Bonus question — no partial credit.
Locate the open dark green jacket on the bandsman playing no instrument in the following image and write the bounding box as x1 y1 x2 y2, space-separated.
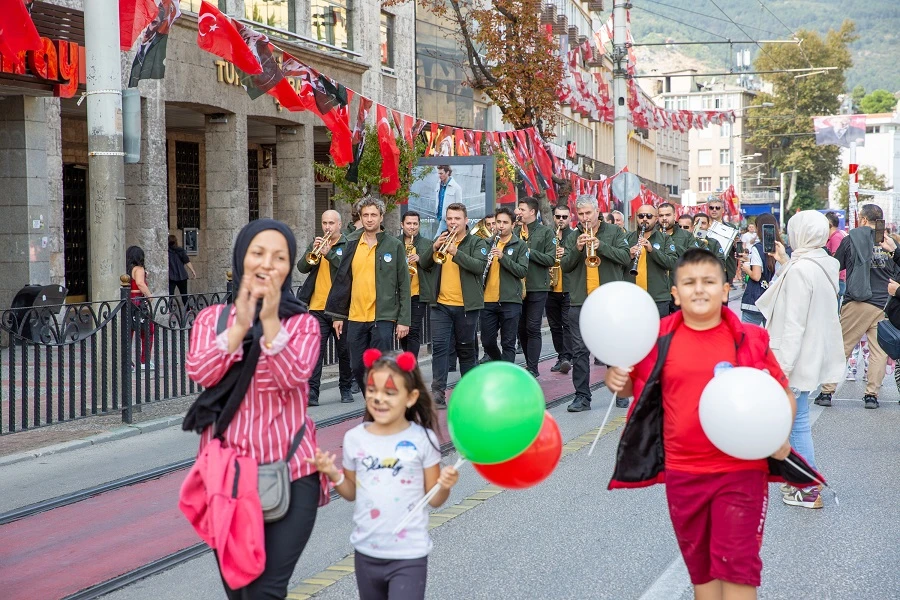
325 229 410 326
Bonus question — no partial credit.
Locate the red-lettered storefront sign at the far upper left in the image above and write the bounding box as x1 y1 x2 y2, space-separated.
0 38 87 98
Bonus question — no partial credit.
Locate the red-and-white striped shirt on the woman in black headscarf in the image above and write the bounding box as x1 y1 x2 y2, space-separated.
185 304 329 506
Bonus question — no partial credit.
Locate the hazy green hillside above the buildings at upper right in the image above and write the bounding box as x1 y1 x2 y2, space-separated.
620 0 900 92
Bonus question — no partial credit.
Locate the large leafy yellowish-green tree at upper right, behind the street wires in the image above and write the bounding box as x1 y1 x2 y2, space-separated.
745 20 857 194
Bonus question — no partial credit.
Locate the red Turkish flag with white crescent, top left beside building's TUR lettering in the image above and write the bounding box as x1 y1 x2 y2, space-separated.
196 0 268 75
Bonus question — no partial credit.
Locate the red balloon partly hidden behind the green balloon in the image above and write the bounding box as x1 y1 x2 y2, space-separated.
472 412 562 490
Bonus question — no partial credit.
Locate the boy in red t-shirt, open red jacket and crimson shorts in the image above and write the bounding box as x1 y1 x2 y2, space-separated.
606 249 796 600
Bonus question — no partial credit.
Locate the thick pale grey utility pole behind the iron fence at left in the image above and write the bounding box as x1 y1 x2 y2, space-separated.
84 0 125 301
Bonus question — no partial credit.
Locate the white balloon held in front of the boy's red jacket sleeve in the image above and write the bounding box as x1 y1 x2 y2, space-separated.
700 367 791 460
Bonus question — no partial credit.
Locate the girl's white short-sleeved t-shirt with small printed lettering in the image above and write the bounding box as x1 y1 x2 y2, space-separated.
343 423 441 559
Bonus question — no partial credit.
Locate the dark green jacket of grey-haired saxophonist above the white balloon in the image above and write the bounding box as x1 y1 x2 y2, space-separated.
561 222 631 306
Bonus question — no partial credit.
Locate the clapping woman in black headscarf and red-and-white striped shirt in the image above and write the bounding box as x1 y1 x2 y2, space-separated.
183 219 328 600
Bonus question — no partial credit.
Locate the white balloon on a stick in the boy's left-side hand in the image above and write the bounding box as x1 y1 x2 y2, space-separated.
578 281 659 368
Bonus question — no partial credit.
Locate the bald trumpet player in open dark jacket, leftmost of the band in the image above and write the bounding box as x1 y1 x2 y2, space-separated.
297 210 353 406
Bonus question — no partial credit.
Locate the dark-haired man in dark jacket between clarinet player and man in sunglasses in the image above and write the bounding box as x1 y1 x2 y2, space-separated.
515 196 556 377
